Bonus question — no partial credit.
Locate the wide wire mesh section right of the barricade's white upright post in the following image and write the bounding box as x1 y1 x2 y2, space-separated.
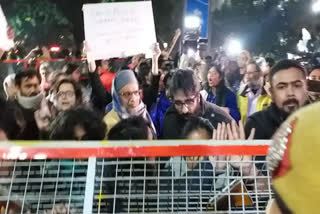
93 157 272 213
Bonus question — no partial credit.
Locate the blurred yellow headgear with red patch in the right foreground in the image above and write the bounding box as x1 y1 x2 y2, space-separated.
266 101 320 214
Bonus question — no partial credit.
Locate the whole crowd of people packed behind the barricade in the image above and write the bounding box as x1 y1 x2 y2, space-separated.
0 26 320 212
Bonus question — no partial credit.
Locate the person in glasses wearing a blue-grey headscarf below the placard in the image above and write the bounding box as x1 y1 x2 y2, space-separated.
103 70 157 138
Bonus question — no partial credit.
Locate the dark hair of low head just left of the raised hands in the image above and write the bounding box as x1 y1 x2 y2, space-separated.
182 117 214 139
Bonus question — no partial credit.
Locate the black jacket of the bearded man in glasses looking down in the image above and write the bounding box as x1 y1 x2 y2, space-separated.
161 98 232 140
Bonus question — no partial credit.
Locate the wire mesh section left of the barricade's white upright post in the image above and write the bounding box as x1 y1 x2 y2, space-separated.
0 159 87 213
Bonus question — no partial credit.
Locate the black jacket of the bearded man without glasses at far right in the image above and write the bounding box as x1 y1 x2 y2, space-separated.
245 103 288 140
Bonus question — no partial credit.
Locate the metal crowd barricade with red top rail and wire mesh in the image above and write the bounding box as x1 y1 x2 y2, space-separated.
0 141 273 214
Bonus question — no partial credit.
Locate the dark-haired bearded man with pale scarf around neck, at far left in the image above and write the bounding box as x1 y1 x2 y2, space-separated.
15 70 43 140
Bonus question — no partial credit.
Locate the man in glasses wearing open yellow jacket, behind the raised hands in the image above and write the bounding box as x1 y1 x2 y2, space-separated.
238 62 271 122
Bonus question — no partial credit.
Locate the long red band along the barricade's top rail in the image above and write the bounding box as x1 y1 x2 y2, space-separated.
0 144 269 160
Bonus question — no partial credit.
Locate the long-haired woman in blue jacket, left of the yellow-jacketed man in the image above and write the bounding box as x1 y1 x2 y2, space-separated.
200 66 240 121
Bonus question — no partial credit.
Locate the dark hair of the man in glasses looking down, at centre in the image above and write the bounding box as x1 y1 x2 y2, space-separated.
170 70 200 95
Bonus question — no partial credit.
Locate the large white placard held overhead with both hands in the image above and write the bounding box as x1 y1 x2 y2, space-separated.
83 1 156 60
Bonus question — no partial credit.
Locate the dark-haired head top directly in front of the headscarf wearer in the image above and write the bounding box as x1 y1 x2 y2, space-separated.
108 117 150 140
